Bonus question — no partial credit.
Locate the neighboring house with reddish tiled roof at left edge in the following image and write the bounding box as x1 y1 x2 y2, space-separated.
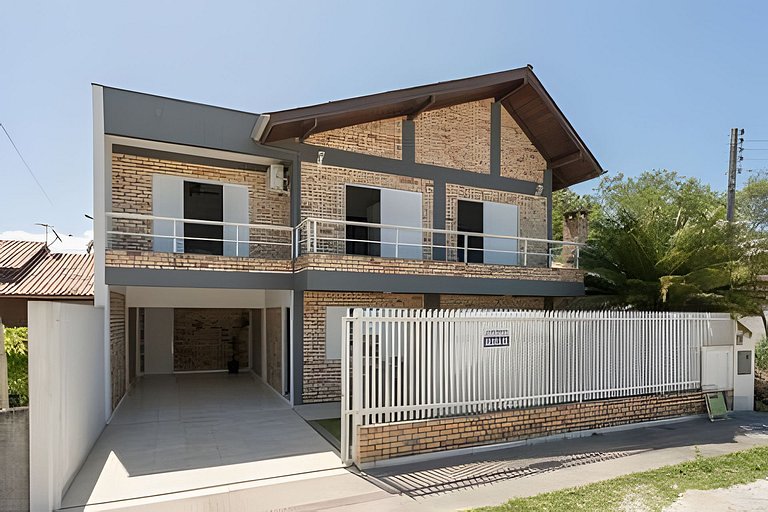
0 240 93 327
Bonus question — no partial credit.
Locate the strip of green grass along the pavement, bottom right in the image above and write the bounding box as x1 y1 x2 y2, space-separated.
476 447 768 512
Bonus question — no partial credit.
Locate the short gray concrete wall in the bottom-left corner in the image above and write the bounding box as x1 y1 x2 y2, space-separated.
0 407 29 512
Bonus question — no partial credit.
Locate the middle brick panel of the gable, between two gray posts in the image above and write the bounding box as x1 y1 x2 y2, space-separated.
414 99 493 174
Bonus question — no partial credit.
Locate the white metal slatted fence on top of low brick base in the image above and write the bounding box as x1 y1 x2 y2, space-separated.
342 309 731 460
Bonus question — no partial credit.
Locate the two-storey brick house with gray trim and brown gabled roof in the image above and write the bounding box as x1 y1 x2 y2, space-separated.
93 68 603 408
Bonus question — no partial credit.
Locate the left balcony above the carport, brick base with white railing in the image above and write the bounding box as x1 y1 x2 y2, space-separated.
106 212 293 272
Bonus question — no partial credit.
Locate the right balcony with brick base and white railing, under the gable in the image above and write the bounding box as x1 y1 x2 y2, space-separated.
294 218 583 281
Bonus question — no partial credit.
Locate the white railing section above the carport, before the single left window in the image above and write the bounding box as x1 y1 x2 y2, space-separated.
107 212 293 259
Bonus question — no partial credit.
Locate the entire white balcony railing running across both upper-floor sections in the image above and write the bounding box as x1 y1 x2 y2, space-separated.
107 212 583 268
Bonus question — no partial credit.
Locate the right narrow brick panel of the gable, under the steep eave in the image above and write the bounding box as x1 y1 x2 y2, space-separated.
501 107 547 183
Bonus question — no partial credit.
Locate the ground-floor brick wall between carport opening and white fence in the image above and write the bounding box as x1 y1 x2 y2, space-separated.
303 292 424 403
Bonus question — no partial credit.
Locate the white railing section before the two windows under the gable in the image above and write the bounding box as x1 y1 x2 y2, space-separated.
294 218 583 268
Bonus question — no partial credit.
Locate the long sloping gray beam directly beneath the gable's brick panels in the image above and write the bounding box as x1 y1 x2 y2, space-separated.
273 142 539 195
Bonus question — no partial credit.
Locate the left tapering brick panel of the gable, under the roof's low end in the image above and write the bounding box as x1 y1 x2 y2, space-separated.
305 118 403 160
